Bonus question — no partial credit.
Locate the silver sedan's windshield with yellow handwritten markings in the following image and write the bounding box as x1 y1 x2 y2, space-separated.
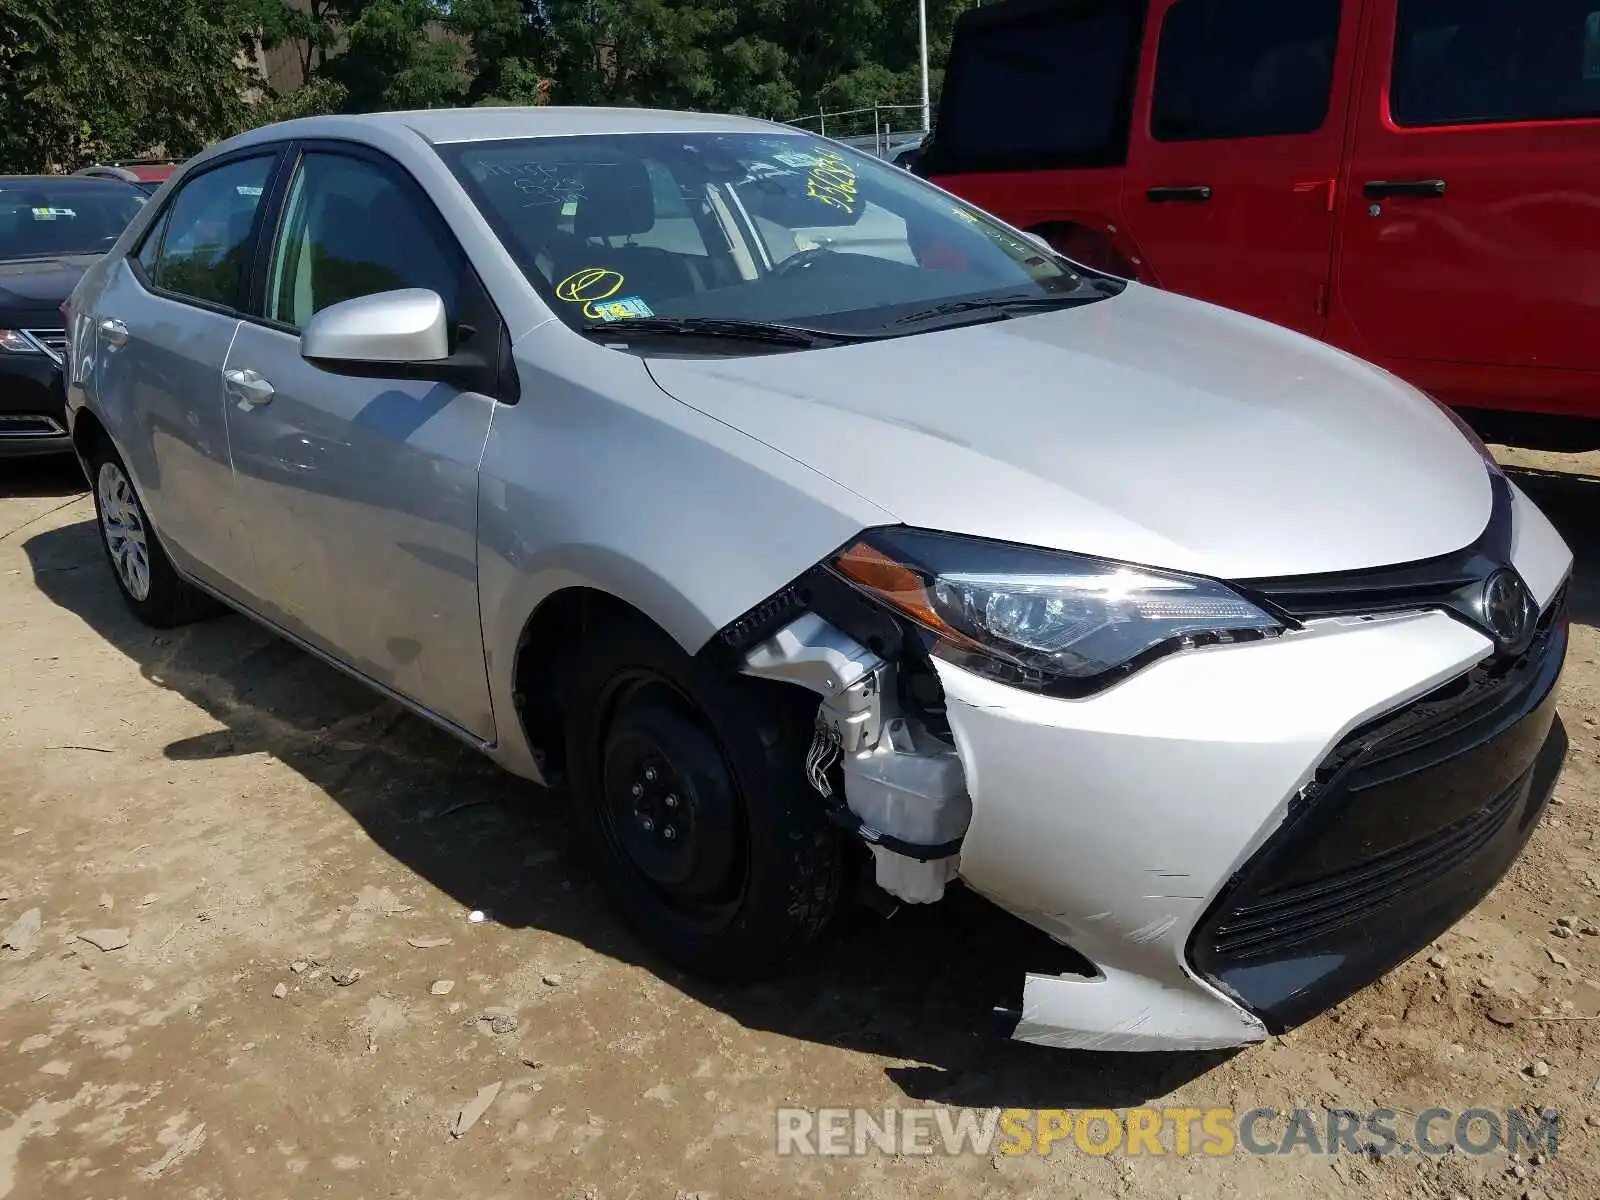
440 131 1120 336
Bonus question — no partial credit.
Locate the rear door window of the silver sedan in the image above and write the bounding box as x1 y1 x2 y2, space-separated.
139 154 274 307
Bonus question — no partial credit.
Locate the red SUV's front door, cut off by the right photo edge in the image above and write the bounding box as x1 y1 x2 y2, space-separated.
1339 0 1600 403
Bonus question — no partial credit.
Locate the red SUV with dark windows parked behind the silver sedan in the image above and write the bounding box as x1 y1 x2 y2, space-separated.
917 0 1600 448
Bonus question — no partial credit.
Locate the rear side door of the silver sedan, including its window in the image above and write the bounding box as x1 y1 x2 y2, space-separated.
85 149 277 590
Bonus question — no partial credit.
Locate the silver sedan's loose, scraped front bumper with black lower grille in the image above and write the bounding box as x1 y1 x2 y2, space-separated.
939 605 1566 1051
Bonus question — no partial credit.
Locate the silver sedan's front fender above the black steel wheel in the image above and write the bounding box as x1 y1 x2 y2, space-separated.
478 322 893 779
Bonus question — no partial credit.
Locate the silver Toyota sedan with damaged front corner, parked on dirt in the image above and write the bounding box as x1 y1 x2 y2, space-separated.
67 109 1571 1050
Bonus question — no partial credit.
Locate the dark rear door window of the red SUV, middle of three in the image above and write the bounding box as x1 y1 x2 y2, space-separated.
1150 0 1350 142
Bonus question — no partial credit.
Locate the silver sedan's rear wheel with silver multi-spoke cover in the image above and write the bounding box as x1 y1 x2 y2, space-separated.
90 440 222 629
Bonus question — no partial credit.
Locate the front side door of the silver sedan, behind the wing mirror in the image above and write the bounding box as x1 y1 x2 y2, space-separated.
224 144 496 741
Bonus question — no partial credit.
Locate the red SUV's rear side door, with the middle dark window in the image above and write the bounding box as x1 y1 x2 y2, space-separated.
1122 0 1360 336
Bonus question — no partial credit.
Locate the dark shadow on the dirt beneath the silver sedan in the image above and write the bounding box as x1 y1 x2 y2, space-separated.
24 522 1229 1109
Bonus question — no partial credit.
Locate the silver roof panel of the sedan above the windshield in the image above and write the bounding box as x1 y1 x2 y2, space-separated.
227 106 800 146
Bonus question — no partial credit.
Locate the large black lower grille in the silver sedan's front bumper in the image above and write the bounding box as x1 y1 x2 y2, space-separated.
1189 594 1568 1030
